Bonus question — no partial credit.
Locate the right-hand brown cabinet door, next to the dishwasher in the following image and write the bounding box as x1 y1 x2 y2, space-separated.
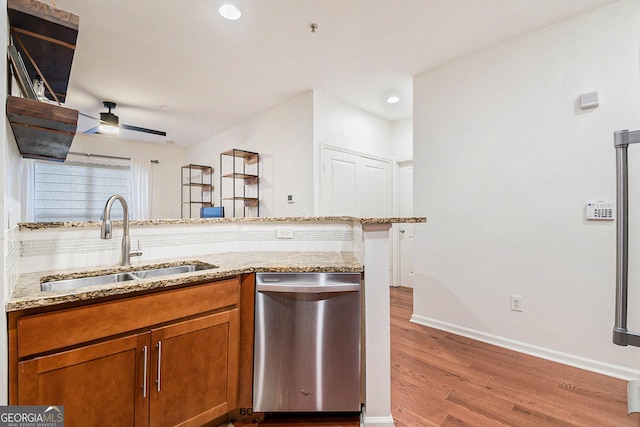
149 309 239 426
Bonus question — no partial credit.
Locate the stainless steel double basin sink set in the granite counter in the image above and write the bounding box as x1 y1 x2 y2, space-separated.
40 263 217 292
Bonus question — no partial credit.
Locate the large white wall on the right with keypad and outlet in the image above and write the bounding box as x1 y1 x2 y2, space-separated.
414 0 640 376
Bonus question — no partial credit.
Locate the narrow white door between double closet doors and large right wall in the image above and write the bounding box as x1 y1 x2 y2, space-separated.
398 162 413 288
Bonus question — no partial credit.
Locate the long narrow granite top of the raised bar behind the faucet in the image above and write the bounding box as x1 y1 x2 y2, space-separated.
18 216 427 230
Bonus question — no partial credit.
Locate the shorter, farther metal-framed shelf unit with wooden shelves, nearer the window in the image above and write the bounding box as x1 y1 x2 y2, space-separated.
180 164 213 218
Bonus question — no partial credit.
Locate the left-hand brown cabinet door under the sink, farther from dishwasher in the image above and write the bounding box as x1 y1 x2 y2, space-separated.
18 333 149 427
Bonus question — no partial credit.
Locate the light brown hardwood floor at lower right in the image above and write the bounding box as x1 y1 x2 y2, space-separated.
391 288 640 427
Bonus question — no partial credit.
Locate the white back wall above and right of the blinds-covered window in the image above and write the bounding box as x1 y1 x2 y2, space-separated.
70 133 188 219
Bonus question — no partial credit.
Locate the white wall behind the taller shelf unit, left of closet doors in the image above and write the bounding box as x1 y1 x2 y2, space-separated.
188 91 313 217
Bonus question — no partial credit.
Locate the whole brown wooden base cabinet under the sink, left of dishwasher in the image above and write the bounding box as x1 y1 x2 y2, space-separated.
9 277 240 426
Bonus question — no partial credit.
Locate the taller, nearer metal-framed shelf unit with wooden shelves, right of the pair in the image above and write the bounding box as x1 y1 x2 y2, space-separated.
220 148 260 217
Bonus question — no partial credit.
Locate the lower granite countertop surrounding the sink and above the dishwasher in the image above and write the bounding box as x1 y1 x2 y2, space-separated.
6 252 363 312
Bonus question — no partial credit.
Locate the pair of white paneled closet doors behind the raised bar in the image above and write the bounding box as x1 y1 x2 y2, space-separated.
320 147 392 217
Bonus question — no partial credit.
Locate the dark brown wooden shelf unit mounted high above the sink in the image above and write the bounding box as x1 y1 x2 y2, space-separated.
7 0 80 161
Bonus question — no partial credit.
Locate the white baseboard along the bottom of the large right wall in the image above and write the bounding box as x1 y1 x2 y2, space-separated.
411 314 640 381
